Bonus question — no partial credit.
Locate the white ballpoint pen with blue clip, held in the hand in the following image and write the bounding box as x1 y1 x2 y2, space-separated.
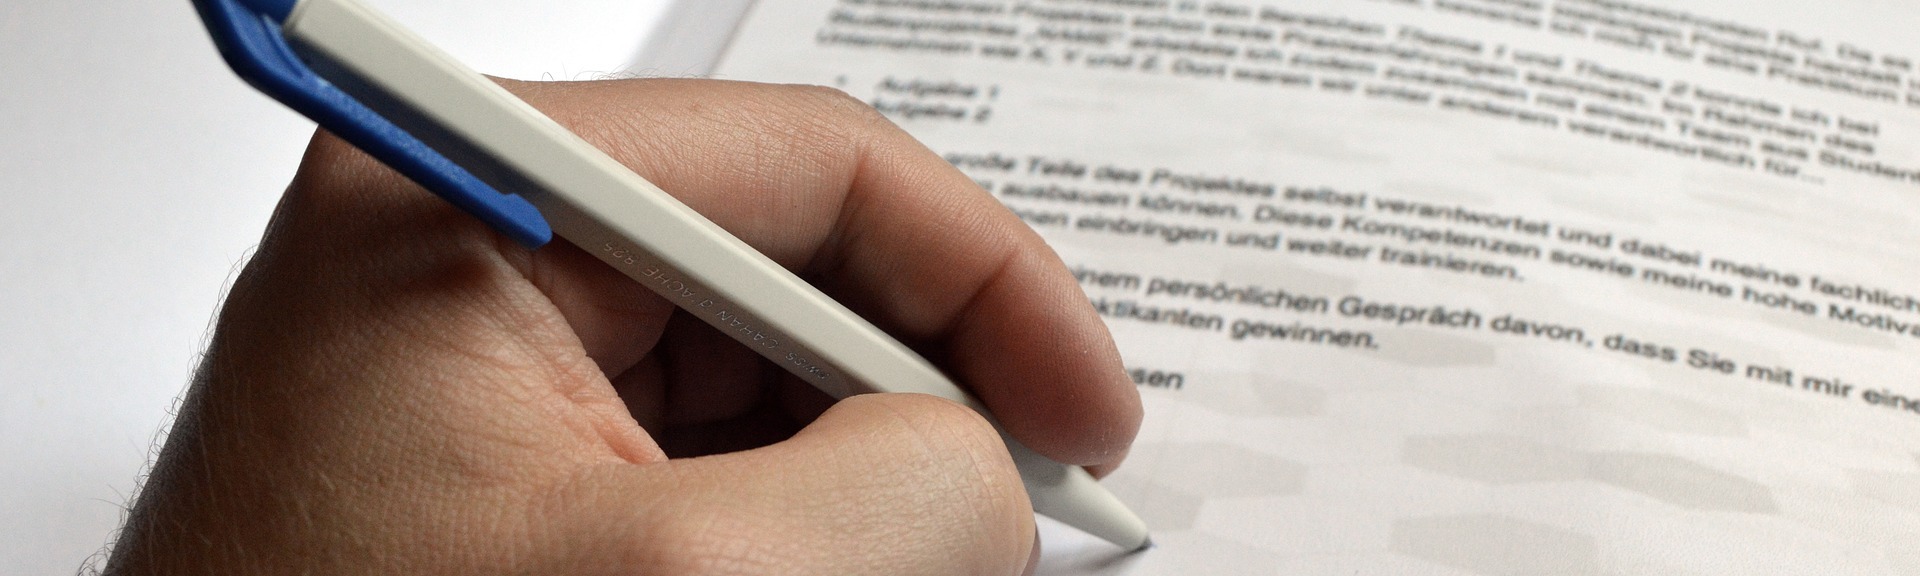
194 0 1148 549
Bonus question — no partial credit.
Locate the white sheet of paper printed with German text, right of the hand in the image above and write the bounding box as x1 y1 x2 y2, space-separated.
698 0 1920 574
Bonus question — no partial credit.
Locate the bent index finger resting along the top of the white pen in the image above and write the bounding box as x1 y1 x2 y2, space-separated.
515 81 1140 465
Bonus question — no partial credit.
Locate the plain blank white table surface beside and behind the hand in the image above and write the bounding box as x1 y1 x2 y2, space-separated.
0 0 674 574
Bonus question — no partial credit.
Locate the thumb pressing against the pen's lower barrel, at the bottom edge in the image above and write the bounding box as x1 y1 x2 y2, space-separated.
545 394 1035 574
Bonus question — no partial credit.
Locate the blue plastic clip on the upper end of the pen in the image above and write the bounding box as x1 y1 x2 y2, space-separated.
194 0 553 248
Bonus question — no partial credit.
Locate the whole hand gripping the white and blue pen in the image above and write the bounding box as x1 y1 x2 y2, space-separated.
108 81 1140 574
